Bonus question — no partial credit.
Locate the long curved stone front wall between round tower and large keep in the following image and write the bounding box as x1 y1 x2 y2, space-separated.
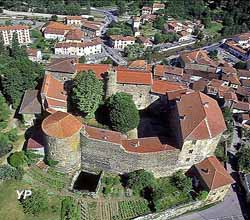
80 133 181 177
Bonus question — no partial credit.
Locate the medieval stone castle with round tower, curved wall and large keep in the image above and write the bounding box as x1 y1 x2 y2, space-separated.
42 65 226 177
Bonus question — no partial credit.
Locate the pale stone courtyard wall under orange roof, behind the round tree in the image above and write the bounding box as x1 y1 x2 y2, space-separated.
116 83 151 109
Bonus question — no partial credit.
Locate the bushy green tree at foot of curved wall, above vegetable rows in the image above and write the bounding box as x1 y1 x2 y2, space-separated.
127 170 156 194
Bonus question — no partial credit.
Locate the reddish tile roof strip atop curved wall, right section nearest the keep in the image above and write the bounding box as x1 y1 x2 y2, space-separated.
122 137 176 153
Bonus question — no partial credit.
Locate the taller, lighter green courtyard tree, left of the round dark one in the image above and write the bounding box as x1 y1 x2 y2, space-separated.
72 71 103 118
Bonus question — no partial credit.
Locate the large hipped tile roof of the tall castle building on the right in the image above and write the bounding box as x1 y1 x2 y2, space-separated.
177 92 226 140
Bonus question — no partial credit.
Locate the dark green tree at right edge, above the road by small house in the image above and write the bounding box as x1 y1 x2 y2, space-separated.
236 144 250 173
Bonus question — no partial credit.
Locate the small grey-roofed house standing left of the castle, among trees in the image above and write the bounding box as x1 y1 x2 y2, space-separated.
18 90 42 126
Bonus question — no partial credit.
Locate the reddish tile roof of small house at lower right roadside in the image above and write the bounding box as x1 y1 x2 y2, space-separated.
194 156 235 190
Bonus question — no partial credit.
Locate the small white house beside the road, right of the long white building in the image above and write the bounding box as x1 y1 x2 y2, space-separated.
110 35 135 50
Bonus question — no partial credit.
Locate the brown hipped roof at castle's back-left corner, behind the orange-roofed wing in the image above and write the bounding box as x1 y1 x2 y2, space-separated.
46 58 77 74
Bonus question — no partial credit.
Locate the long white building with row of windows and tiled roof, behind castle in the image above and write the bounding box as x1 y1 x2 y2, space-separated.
55 39 102 57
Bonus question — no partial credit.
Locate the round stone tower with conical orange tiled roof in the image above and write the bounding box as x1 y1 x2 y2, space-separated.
42 112 82 173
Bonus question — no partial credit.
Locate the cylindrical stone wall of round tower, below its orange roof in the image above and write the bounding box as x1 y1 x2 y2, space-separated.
44 131 81 173
